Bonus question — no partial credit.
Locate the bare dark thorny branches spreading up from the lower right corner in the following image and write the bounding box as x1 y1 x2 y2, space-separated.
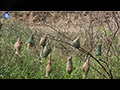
39 12 119 79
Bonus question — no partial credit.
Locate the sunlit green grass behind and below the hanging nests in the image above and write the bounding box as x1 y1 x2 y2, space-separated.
0 19 120 79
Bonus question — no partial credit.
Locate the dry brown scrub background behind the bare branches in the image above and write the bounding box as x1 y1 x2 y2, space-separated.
0 11 120 79
